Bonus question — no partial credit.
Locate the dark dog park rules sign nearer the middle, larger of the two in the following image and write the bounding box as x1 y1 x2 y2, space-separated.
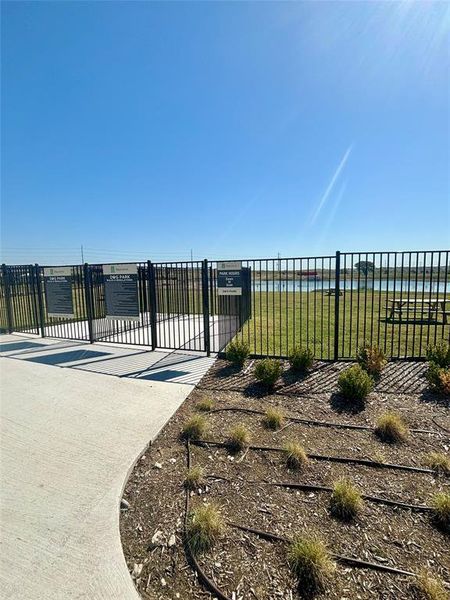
103 263 139 321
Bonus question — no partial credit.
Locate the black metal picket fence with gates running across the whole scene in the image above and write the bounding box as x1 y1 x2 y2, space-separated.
0 250 450 360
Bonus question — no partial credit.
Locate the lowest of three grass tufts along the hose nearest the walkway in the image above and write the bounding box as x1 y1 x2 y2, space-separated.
186 504 224 554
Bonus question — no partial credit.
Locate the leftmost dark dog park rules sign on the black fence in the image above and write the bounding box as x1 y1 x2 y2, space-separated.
44 267 75 317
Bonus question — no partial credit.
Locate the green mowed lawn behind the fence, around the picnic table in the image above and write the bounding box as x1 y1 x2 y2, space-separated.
239 289 450 359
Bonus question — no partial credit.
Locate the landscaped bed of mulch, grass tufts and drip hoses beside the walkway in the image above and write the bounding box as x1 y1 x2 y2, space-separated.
120 360 450 600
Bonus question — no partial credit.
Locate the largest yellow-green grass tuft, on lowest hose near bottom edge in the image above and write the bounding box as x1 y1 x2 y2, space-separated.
287 536 334 592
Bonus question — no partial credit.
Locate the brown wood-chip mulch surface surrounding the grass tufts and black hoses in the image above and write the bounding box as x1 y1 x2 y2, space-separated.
120 360 450 600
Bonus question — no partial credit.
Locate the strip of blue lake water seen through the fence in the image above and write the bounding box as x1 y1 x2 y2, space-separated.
252 279 450 296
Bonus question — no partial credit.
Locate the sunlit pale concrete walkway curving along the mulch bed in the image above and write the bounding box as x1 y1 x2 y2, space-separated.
0 336 197 600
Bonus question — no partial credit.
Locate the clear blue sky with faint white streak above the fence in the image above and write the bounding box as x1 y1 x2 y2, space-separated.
1 1 450 264
